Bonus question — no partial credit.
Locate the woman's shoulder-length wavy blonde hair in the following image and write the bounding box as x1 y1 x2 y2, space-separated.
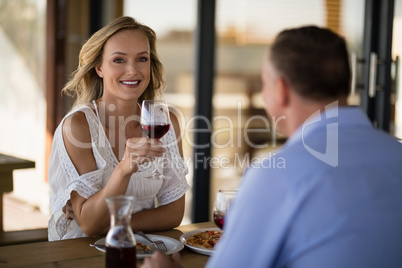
62 17 165 107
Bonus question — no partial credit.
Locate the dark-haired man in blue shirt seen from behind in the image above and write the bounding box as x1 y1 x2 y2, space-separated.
139 26 402 268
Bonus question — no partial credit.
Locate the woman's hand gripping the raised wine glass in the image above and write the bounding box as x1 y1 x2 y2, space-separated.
120 137 166 174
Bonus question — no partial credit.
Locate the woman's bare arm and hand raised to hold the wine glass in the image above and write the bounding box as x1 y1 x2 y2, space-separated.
63 112 165 236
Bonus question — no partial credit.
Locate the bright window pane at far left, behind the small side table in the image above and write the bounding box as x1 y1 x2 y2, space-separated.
0 0 48 231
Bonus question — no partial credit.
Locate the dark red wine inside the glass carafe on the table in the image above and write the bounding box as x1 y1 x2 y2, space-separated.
106 246 136 268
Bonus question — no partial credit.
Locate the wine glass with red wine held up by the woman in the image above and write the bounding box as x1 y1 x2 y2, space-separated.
141 100 170 179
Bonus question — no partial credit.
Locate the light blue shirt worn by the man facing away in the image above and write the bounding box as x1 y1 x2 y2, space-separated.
208 107 402 268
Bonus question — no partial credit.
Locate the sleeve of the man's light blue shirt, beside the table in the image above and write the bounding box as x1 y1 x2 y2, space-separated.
207 165 294 267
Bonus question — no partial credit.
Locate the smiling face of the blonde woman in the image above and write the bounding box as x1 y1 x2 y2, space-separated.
96 30 151 101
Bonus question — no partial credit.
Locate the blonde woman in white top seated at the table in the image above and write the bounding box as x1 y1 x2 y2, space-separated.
49 17 189 241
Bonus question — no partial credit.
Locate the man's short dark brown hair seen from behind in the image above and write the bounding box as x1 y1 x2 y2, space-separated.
270 26 350 99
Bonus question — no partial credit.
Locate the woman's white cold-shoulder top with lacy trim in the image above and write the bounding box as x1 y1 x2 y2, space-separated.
48 102 190 241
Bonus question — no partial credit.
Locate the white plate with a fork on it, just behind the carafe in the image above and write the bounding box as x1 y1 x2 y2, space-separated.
94 234 184 259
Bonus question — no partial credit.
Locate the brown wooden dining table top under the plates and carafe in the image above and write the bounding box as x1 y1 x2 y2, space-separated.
0 222 216 268
